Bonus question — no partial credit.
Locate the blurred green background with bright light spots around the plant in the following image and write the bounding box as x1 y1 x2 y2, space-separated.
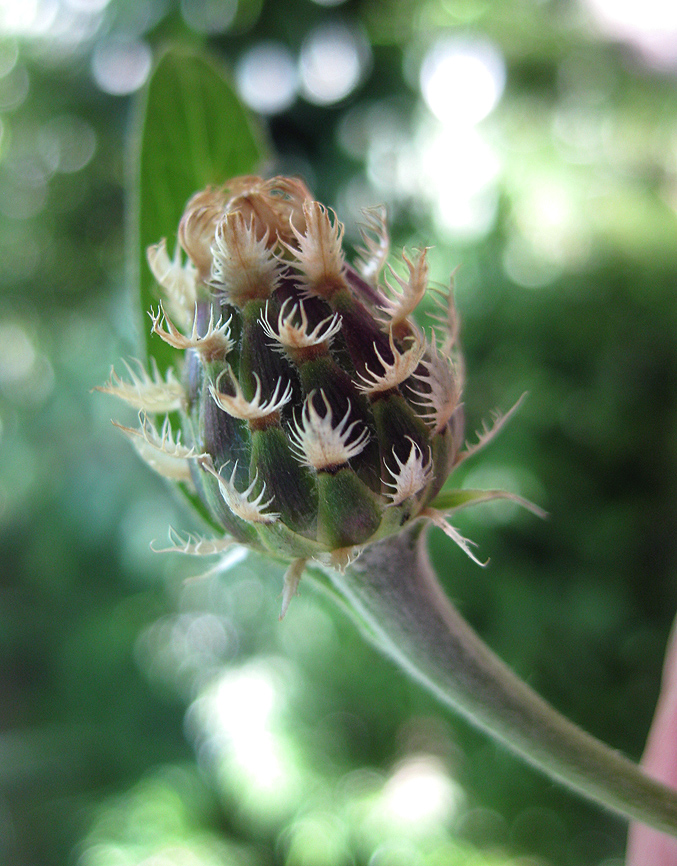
0 0 677 866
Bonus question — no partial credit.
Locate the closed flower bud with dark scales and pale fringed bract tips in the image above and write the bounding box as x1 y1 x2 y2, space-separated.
102 177 532 613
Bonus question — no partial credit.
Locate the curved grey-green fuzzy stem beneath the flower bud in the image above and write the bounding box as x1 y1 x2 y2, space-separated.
310 526 677 836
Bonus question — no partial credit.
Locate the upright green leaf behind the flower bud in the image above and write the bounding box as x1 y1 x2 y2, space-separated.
129 48 266 371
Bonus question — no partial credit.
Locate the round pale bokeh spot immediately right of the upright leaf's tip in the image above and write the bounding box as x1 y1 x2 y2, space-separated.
235 42 297 114
